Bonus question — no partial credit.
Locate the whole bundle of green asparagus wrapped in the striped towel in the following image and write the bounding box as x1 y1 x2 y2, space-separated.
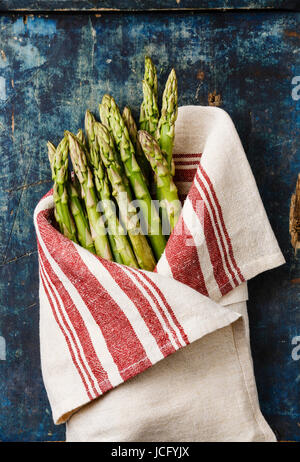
48 57 181 271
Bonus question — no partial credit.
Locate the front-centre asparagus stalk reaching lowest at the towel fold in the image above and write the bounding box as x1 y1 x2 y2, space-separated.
94 122 156 271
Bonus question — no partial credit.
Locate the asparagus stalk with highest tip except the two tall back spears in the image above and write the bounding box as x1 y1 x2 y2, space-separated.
100 95 166 259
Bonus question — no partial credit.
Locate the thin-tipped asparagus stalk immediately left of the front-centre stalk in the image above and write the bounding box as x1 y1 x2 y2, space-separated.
85 111 138 268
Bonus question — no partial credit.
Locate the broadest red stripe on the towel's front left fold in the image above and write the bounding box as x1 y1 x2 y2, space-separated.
37 210 152 380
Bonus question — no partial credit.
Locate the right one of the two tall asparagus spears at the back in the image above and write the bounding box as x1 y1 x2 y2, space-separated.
156 69 178 175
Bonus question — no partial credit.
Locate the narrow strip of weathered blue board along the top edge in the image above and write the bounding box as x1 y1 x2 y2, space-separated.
0 0 300 12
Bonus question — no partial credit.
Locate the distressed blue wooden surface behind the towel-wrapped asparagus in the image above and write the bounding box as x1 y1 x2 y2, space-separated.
0 6 300 441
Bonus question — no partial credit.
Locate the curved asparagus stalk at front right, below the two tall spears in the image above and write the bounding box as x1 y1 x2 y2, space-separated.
138 130 181 232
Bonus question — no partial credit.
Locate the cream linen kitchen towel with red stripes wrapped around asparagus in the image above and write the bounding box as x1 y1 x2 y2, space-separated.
34 106 284 441
